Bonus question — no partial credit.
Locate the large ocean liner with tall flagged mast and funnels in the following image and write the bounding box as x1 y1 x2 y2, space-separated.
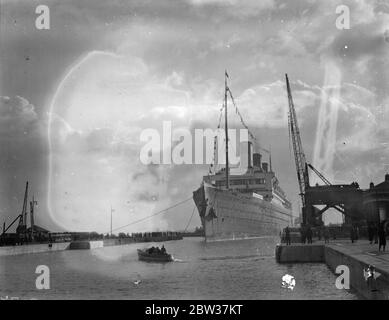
193 72 292 241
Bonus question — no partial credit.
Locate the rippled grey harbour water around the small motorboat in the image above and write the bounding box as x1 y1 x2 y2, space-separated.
0 238 356 299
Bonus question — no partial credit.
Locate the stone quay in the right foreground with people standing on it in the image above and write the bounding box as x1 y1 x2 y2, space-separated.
276 240 389 300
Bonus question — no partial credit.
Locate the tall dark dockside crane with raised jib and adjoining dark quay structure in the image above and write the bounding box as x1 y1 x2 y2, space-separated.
285 75 389 226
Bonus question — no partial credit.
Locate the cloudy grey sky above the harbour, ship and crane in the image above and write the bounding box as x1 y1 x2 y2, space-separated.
0 0 389 233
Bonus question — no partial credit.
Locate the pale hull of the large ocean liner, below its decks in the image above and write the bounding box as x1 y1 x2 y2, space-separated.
193 183 292 241
